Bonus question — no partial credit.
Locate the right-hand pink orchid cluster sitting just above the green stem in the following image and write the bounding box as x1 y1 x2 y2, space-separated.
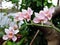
33 7 55 23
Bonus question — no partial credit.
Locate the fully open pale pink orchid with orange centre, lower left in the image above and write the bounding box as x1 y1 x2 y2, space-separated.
3 27 19 41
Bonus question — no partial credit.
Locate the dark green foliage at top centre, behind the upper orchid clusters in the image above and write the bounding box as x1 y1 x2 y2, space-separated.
20 0 52 12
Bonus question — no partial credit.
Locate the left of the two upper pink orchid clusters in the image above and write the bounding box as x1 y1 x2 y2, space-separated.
15 7 33 21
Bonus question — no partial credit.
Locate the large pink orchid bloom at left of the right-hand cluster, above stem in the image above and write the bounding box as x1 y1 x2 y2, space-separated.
33 11 47 23
